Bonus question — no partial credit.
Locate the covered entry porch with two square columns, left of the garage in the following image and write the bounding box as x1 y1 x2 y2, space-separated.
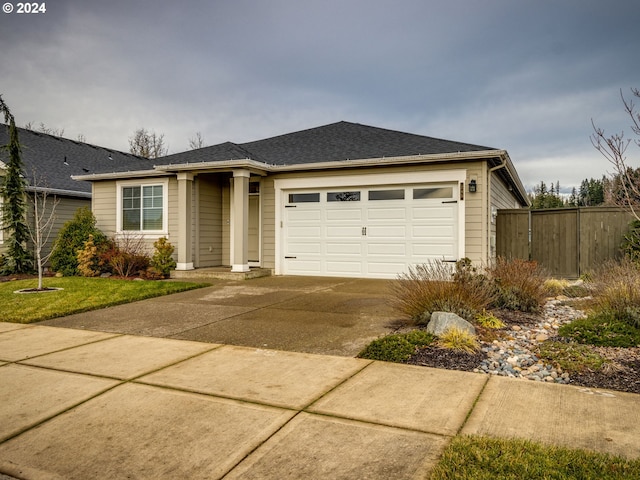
160 161 271 278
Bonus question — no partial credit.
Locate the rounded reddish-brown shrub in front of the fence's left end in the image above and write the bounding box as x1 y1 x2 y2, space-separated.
488 257 546 313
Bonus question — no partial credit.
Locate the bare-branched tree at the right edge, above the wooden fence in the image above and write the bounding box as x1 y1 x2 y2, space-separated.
591 88 640 221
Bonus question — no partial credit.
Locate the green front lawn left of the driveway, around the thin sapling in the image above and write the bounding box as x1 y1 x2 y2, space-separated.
0 277 210 323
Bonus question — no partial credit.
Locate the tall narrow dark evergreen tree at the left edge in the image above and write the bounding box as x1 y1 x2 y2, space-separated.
0 95 33 273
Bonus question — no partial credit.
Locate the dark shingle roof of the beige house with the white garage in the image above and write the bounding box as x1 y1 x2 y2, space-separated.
148 122 495 169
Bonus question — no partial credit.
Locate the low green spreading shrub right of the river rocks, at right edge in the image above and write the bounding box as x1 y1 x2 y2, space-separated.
558 312 640 348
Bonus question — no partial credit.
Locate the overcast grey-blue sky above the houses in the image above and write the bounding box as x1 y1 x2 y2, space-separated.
0 0 640 188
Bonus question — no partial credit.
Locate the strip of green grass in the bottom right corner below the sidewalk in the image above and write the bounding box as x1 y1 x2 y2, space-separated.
429 436 640 480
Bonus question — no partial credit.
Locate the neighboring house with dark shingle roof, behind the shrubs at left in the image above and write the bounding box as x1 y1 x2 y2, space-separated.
0 124 153 254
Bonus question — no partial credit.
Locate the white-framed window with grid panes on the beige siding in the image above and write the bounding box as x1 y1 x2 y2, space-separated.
116 179 169 235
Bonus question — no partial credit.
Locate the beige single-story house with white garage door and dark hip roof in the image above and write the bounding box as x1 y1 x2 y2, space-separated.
73 122 528 278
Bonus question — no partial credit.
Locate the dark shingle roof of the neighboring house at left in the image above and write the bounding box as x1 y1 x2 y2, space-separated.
0 124 154 193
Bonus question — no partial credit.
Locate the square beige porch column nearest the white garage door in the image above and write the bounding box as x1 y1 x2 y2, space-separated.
231 170 250 272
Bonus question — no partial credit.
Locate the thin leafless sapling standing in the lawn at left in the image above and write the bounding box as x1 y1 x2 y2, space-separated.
28 176 60 290
